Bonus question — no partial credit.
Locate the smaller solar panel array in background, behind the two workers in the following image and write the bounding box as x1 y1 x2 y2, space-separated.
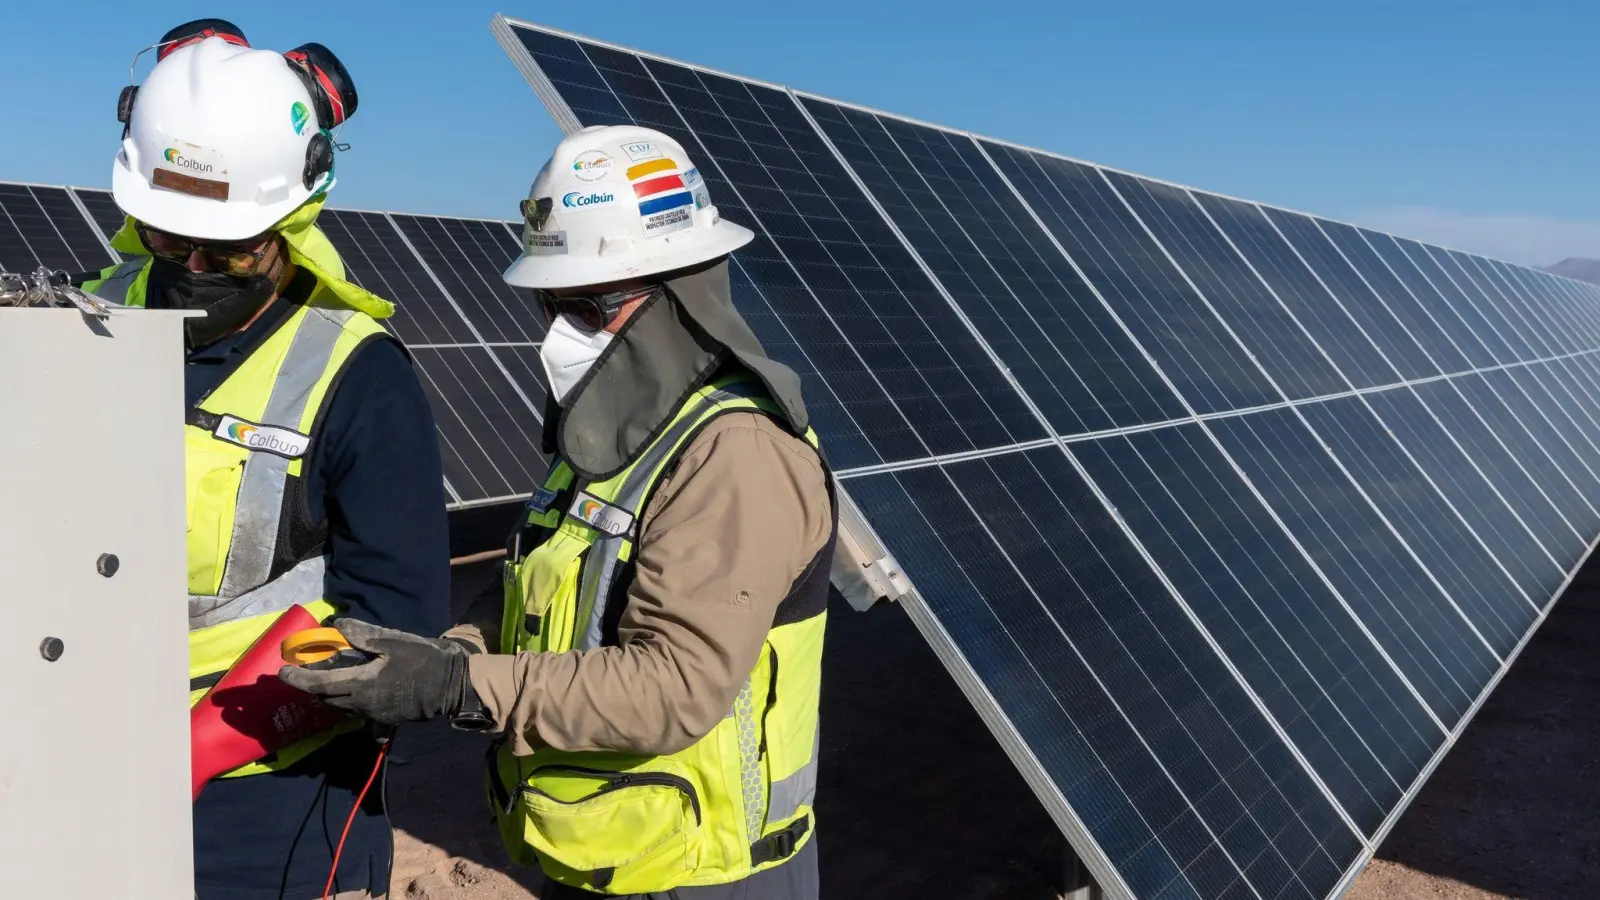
0 183 546 509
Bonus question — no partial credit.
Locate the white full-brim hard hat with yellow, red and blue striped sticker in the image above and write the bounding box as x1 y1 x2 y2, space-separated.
504 125 755 288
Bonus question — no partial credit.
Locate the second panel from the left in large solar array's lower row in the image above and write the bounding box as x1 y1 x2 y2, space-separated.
1074 424 1445 830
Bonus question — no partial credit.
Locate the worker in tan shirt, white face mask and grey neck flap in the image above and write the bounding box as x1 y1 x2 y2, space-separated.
282 127 837 900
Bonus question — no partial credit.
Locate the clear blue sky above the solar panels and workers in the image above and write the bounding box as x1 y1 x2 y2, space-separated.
0 0 1600 263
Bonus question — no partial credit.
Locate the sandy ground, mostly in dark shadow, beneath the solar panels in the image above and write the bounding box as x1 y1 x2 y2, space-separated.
390 565 1600 900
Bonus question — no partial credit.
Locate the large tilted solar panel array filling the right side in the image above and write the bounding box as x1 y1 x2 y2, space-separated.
493 19 1600 900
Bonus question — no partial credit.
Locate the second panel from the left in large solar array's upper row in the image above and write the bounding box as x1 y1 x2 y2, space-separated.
805 99 1182 434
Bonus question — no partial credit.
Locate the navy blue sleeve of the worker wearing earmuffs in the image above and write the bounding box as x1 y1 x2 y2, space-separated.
307 340 450 637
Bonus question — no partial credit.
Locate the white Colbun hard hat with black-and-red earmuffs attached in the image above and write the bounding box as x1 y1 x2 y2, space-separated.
110 37 333 240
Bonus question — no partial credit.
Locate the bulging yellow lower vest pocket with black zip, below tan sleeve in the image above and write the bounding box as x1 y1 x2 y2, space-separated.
512 757 701 894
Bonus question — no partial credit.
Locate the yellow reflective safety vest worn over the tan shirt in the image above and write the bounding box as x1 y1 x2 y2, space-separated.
488 373 837 894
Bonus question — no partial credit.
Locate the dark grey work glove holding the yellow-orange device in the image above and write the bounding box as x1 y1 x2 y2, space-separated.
278 618 467 725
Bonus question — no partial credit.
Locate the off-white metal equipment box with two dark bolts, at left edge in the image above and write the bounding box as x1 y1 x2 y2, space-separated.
0 307 194 900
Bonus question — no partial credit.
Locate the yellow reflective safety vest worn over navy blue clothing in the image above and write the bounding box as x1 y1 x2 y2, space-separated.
83 258 392 778
